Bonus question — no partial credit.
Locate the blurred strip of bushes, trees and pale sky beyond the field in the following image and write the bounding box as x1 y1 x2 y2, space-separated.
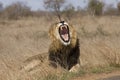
0 0 120 19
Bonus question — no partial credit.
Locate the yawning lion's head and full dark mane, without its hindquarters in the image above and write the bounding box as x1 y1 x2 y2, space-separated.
48 21 80 71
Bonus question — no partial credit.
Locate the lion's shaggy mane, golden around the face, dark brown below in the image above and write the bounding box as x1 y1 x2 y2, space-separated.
49 21 80 70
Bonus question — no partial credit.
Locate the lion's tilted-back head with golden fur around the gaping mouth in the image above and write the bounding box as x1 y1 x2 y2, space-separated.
49 21 77 47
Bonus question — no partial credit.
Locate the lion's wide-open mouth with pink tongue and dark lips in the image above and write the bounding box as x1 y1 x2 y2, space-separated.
59 25 70 42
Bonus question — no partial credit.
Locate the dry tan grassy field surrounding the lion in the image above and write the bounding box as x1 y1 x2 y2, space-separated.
0 16 120 80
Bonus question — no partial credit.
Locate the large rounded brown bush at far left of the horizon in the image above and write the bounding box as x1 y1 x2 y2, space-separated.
2 2 31 19
